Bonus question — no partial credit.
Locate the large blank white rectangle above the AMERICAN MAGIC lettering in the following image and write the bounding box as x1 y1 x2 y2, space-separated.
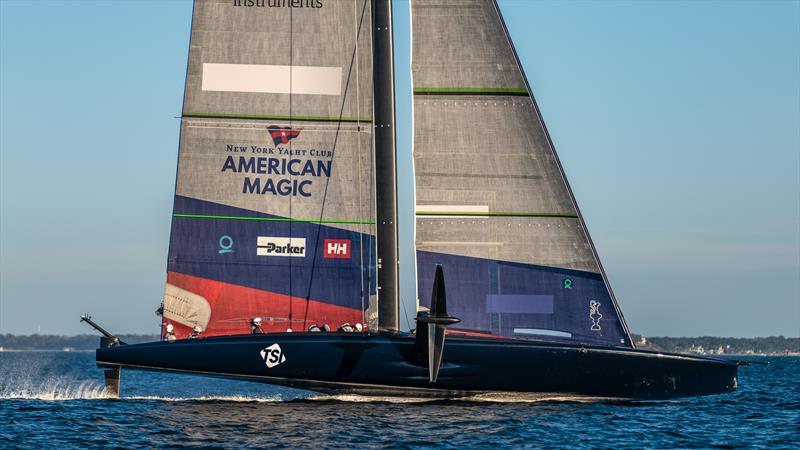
202 63 342 95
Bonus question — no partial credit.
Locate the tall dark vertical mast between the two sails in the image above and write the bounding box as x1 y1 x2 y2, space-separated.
372 0 399 332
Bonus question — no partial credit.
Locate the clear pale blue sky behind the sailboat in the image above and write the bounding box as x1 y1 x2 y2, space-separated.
0 0 800 336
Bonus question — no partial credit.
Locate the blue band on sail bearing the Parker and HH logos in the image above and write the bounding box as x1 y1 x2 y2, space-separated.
168 196 376 310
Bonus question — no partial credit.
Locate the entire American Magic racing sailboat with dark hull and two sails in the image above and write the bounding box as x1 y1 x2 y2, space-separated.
83 0 737 398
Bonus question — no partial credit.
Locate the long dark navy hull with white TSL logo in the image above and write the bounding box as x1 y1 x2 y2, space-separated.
97 333 737 398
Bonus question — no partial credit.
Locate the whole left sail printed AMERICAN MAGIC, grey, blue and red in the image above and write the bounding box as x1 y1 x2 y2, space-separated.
164 0 376 337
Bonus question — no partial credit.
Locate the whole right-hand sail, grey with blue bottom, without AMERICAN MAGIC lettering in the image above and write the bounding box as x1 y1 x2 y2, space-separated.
411 0 632 346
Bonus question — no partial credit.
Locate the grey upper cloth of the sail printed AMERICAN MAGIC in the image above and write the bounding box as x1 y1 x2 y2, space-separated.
183 0 374 227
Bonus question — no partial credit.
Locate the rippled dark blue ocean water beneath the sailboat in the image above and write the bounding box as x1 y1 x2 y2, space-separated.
0 352 800 449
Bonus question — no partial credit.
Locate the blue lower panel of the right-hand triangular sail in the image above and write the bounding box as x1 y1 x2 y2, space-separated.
417 251 625 346
